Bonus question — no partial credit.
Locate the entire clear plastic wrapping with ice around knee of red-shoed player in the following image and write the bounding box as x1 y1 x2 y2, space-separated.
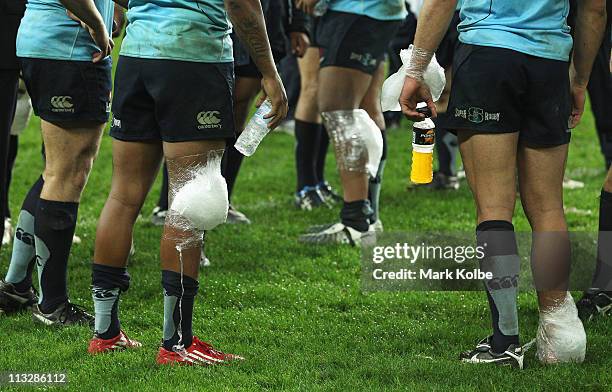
166 150 229 245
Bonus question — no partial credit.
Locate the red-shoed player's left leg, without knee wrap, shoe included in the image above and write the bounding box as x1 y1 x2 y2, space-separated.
88 139 162 354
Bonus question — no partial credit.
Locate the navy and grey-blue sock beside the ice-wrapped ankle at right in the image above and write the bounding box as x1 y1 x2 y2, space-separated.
476 220 520 353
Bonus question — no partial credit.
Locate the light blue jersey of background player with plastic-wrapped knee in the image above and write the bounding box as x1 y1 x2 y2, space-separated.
329 0 407 20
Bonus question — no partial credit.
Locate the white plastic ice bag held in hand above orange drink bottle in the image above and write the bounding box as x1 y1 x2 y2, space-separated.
380 45 446 112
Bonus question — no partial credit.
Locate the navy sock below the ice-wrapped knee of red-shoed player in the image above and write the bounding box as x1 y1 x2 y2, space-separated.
162 270 198 351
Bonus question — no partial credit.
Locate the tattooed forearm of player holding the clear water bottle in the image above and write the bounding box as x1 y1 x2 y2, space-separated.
225 0 277 77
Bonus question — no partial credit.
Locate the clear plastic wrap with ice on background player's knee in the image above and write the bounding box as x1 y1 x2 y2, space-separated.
322 109 383 177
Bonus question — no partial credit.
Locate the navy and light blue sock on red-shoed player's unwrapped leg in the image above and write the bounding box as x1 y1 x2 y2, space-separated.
91 263 130 339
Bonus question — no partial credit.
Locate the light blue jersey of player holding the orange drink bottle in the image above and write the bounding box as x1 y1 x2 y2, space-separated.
458 0 573 61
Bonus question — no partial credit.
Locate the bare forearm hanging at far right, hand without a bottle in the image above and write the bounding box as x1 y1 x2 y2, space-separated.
572 0 606 87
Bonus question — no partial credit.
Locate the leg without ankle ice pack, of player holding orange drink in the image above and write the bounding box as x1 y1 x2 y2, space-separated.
459 131 520 356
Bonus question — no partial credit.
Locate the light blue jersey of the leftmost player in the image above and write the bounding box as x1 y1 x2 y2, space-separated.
17 0 114 61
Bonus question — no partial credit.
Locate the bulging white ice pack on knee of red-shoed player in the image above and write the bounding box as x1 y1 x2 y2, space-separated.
170 154 229 231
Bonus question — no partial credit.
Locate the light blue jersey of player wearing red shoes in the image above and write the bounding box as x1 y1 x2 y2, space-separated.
121 0 233 63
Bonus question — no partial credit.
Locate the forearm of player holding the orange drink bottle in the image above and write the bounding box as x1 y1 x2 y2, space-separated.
406 0 457 80
